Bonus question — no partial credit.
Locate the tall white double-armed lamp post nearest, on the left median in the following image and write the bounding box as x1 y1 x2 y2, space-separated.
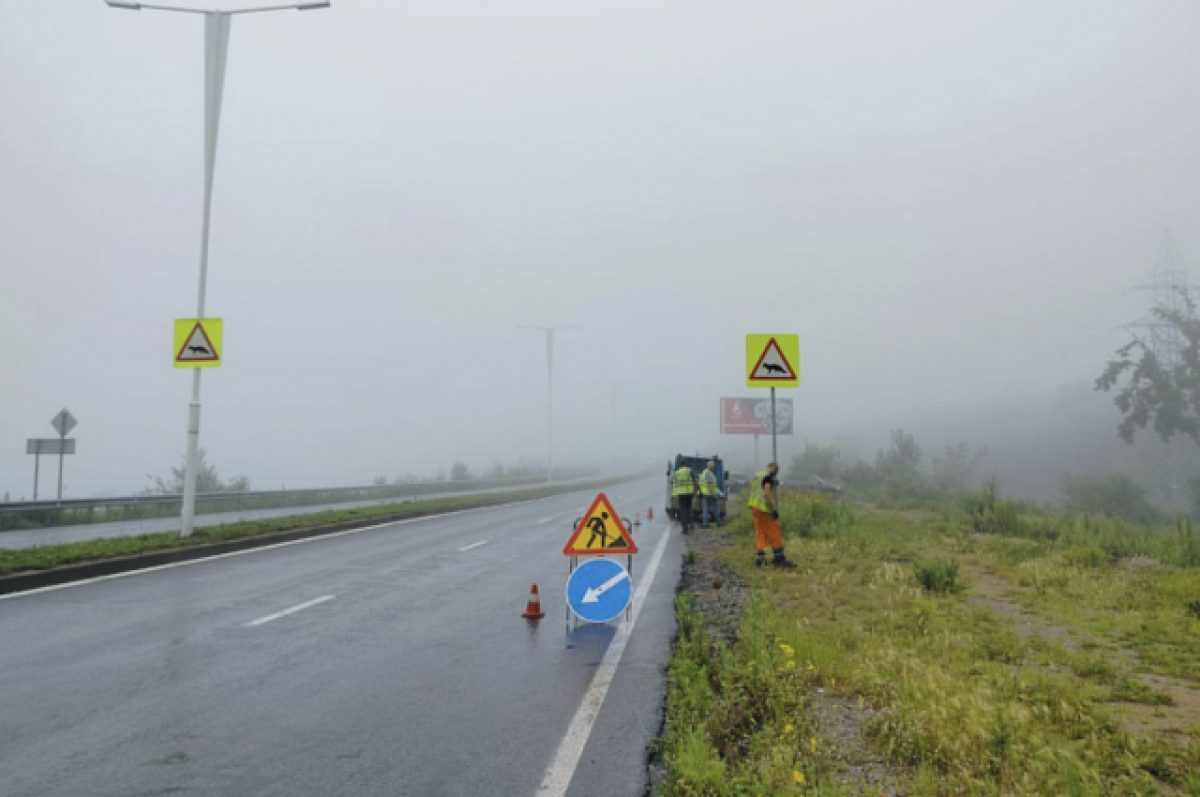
104 0 329 537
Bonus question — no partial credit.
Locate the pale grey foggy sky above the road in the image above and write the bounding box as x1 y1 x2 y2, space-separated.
0 0 1200 498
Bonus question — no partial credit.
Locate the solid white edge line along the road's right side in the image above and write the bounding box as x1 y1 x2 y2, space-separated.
538 527 671 797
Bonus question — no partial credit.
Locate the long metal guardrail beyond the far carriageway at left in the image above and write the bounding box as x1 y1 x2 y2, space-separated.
0 473 595 532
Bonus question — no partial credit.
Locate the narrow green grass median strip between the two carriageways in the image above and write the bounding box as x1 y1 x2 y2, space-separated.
0 483 638 575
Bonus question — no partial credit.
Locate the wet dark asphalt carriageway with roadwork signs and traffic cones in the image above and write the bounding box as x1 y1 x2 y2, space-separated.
0 479 683 797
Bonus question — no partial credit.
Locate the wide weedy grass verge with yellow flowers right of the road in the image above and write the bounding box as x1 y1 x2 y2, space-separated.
662 496 1200 797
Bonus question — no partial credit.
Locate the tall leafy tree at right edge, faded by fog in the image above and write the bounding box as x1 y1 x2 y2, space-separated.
1096 289 1200 445
